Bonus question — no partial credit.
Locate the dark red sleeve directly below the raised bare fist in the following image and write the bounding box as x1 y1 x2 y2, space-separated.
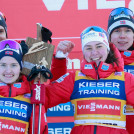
51 56 67 82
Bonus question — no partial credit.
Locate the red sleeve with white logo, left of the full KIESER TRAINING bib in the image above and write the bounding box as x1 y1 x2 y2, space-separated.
45 72 75 108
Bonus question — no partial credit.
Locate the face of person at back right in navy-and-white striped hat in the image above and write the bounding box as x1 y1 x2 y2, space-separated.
111 27 134 51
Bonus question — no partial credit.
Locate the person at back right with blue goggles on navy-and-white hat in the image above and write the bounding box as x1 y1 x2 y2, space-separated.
108 7 134 134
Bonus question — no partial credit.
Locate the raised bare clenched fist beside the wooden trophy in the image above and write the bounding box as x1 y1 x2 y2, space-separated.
56 40 74 54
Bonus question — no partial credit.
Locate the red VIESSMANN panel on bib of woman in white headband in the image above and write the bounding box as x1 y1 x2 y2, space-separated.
77 100 121 115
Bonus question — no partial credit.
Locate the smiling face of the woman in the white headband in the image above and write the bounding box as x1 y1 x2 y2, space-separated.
83 41 108 65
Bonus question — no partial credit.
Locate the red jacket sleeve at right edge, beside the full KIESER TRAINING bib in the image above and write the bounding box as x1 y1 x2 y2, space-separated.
125 72 134 105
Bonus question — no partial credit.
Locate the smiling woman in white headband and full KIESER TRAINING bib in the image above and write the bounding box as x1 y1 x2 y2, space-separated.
45 26 134 134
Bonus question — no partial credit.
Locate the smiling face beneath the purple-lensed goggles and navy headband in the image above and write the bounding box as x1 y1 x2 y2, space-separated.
0 56 20 84
